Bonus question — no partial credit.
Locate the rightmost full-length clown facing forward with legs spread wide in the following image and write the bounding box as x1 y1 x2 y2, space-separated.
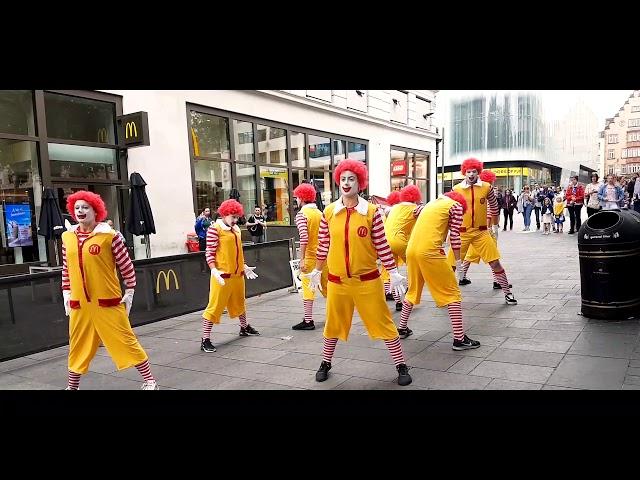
449 158 518 305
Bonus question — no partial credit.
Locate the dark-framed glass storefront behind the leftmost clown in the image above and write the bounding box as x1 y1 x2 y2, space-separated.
0 90 135 276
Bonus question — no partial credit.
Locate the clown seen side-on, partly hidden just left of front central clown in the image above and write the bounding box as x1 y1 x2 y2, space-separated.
291 183 327 330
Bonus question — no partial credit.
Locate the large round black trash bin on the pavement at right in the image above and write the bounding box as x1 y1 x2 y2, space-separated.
578 210 640 320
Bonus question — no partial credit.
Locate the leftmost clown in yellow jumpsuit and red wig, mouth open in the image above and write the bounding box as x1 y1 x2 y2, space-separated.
62 190 158 390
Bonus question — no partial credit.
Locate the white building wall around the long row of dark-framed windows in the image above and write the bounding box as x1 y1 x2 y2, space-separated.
105 90 438 257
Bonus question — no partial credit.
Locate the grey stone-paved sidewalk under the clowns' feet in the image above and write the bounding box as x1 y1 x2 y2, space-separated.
0 212 640 390
